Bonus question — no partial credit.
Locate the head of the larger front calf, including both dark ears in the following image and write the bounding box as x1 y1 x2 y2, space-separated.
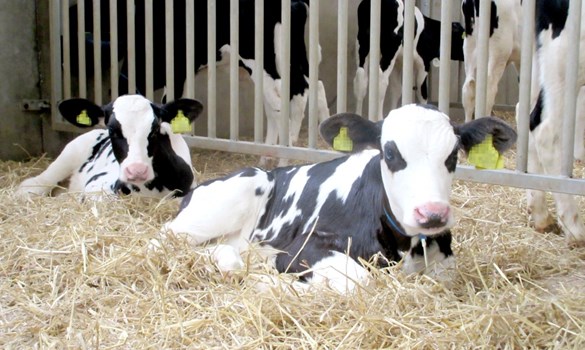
320 105 516 236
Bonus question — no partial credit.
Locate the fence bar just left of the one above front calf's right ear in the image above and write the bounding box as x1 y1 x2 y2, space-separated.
436 0 453 114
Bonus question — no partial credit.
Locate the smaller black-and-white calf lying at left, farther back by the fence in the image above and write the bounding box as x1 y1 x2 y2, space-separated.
18 95 203 197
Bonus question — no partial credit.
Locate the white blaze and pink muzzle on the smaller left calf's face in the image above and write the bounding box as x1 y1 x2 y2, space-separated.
113 95 156 183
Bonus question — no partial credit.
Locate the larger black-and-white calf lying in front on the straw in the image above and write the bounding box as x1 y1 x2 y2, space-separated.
153 105 516 292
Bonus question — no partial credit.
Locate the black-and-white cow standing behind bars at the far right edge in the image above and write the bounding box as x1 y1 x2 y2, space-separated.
528 0 585 244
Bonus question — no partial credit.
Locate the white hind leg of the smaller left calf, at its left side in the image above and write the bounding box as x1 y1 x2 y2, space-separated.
16 130 107 196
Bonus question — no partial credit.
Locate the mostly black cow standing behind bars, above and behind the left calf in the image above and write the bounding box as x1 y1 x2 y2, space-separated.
66 0 329 156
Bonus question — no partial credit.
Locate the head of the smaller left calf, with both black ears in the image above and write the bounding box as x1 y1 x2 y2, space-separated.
59 95 203 184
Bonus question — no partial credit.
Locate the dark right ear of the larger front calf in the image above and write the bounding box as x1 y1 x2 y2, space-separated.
454 117 518 153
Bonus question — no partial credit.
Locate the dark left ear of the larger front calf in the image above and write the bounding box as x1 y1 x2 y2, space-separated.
319 113 382 152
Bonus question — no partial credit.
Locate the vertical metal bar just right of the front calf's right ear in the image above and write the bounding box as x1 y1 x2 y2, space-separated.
516 0 535 173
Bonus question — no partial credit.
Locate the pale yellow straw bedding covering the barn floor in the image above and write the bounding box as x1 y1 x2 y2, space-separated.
0 131 585 349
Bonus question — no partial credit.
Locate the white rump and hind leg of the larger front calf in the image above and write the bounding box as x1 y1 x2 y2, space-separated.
152 169 274 271
